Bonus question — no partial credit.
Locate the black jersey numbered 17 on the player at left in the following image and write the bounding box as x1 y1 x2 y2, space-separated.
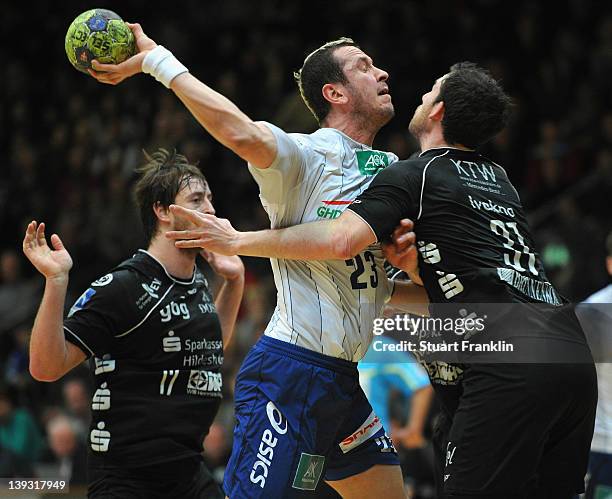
64 250 223 468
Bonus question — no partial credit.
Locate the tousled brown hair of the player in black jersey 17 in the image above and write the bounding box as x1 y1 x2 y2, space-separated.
134 149 207 244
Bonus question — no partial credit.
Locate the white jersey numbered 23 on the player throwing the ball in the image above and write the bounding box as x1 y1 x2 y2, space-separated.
249 123 398 362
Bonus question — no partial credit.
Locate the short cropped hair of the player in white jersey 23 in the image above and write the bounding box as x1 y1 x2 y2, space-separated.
293 37 357 125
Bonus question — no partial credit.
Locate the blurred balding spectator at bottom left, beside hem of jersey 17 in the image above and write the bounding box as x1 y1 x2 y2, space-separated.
47 415 87 486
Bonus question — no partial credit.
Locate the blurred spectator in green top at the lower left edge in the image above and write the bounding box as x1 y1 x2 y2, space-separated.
0 386 44 465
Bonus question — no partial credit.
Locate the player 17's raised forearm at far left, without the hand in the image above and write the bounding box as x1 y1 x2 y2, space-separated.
30 275 68 381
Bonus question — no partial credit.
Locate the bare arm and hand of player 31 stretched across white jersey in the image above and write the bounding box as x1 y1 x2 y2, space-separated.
166 205 376 260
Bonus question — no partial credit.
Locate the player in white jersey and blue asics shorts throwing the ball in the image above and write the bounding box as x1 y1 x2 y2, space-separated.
91 25 426 499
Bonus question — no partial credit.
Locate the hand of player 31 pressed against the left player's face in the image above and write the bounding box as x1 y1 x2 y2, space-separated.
166 204 238 255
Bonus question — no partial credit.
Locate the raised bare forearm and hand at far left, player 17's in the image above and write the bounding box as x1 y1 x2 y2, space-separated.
23 222 86 381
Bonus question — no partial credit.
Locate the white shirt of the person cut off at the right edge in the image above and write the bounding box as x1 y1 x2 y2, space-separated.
584 284 612 454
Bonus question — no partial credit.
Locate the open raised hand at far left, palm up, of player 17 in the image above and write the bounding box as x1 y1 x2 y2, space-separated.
23 221 72 279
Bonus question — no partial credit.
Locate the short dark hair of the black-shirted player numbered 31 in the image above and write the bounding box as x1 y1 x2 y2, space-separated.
436 62 512 149
